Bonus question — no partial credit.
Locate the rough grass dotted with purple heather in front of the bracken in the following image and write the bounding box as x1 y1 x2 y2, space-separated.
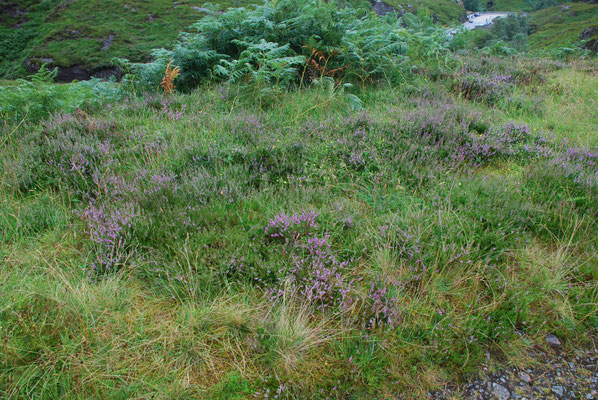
0 51 598 399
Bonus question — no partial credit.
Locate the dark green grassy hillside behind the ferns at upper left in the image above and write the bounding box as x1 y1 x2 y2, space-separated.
0 0 255 77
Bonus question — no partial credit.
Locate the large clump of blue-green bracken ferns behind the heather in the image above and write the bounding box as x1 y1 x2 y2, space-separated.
126 0 447 89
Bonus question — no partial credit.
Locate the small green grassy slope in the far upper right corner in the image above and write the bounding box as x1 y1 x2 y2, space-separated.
529 3 598 49
